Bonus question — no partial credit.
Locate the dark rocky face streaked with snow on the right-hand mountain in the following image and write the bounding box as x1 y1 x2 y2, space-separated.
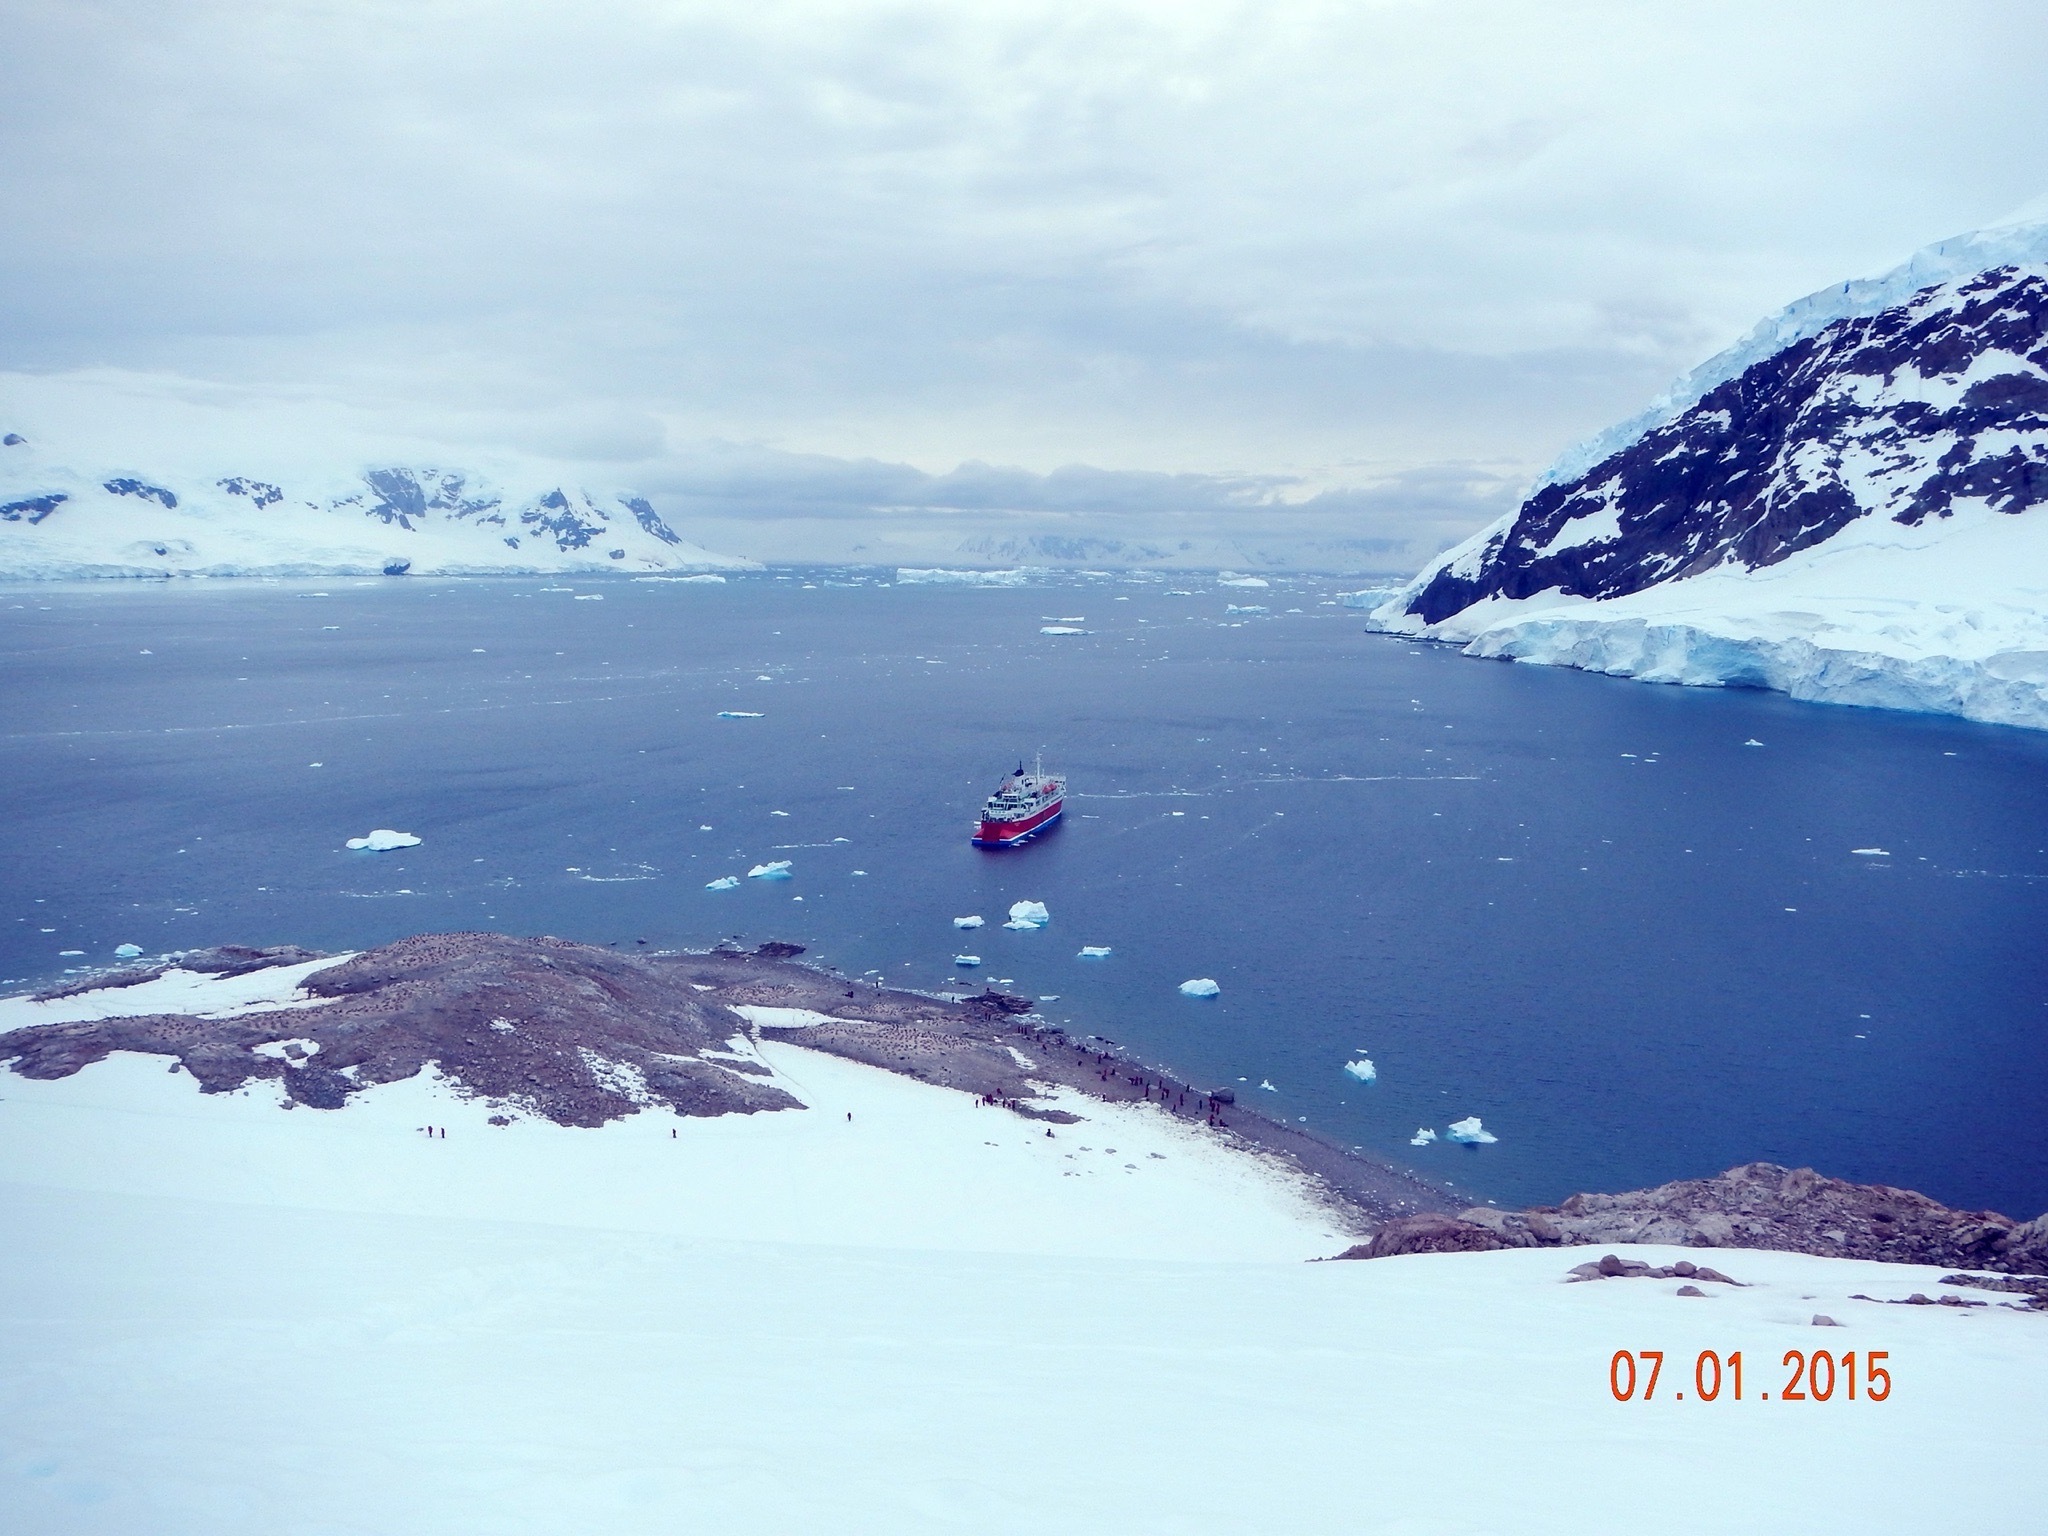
1407 266 2048 623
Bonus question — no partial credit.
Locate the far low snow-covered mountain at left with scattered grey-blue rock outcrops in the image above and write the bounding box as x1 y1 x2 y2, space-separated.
0 405 752 578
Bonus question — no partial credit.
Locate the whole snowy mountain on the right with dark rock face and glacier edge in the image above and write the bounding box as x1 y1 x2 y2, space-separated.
1374 211 2048 727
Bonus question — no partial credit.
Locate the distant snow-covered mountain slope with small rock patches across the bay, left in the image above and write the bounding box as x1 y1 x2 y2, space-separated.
0 379 752 578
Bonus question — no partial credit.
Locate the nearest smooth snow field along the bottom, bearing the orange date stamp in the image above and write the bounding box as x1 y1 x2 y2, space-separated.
0 1163 2048 1536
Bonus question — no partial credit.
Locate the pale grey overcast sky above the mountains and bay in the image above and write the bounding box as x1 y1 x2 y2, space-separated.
0 0 2048 565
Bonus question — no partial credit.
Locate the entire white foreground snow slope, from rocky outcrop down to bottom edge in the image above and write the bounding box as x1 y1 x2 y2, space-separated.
0 1042 2048 1536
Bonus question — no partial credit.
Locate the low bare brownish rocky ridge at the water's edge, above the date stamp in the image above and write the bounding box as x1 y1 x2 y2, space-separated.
1339 1163 2048 1274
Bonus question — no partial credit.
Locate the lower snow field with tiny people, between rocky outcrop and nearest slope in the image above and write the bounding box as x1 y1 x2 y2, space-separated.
0 1040 1350 1262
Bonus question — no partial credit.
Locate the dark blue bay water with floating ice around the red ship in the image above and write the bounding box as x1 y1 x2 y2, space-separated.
0 571 2048 1217
